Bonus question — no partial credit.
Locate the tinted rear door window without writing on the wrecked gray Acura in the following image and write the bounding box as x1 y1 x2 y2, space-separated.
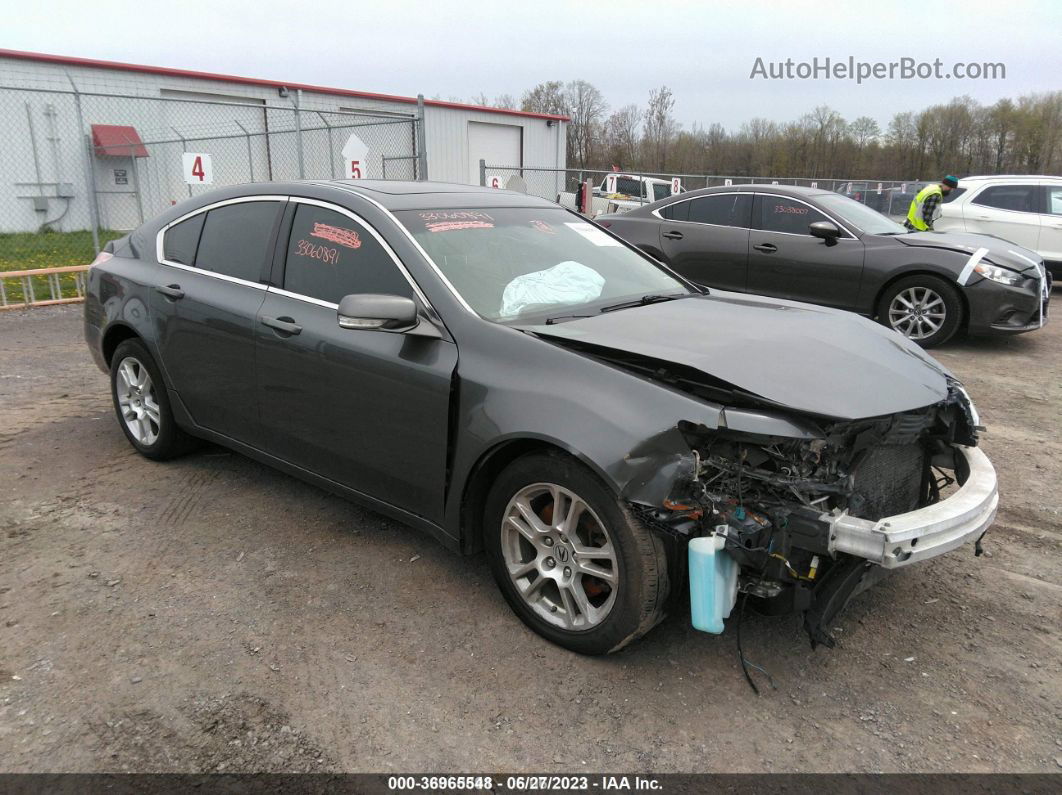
195 202 284 282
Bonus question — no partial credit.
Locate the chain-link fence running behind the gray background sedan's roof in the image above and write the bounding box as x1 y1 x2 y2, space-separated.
480 161 928 219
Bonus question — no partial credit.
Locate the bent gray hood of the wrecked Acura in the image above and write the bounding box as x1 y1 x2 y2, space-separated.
524 290 949 419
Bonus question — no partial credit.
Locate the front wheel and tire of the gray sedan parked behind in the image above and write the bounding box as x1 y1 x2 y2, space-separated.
877 274 962 348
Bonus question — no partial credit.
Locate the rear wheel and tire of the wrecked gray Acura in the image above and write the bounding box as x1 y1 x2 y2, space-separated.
110 340 196 461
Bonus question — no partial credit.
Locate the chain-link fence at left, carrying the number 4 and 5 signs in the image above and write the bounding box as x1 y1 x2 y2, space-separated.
0 74 424 303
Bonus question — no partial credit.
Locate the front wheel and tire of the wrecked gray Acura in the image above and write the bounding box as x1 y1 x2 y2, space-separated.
483 453 669 655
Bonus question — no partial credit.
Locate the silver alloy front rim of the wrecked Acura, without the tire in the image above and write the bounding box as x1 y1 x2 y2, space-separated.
501 483 619 630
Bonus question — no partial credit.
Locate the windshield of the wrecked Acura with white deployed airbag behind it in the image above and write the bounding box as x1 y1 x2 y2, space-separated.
395 207 691 323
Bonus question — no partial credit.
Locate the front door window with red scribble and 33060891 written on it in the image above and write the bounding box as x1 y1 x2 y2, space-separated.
284 204 413 304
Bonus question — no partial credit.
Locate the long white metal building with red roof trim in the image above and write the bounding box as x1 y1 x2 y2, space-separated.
0 50 568 232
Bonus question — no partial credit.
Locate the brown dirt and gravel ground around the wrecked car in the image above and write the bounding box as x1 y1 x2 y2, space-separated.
0 301 1062 773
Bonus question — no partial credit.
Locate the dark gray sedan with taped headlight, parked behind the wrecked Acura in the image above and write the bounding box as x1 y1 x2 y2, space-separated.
597 185 1050 347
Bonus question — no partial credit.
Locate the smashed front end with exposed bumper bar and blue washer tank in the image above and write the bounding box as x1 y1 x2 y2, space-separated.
630 380 998 647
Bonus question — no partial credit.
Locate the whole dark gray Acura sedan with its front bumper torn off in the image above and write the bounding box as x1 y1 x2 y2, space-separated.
85 182 997 654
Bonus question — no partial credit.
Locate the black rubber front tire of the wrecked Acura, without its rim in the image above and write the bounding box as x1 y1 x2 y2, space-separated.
483 453 669 655
